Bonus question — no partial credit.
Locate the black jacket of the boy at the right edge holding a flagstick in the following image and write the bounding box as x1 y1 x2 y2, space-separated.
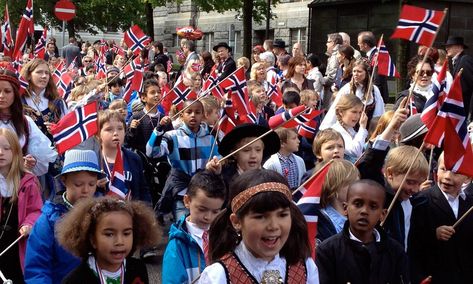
408 186 473 284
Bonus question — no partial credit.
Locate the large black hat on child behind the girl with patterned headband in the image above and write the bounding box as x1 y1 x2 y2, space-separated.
218 123 281 159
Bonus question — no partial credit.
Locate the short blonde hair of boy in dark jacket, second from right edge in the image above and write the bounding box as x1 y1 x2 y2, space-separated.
384 145 429 178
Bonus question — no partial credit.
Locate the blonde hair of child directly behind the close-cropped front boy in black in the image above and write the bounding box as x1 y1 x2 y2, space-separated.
320 159 360 208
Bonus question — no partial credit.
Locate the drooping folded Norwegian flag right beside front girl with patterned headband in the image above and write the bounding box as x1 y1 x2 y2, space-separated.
293 163 331 259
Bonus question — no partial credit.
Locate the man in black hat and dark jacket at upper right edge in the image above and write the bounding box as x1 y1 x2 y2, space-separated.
445 36 473 121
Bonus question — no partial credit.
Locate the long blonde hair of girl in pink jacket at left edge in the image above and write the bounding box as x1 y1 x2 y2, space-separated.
0 128 25 203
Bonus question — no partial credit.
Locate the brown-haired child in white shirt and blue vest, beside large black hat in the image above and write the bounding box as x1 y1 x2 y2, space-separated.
263 127 306 190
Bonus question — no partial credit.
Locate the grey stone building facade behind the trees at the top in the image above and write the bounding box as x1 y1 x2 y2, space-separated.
154 0 310 57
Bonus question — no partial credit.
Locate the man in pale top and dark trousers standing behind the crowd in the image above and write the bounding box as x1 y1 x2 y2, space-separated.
322 33 343 109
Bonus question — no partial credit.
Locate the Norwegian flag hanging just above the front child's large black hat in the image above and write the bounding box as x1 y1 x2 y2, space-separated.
218 67 250 115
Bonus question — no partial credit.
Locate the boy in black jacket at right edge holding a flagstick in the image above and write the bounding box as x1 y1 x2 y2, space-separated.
408 154 473 283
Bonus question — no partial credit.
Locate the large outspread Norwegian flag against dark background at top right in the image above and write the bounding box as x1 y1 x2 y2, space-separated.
391 5 445 46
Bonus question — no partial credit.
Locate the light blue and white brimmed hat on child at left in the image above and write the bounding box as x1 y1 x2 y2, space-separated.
60 149 102 175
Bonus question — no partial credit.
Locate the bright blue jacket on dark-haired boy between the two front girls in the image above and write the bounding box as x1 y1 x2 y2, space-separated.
162 216 205 284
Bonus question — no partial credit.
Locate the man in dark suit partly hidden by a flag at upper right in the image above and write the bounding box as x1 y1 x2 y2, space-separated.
358 31 389 102
